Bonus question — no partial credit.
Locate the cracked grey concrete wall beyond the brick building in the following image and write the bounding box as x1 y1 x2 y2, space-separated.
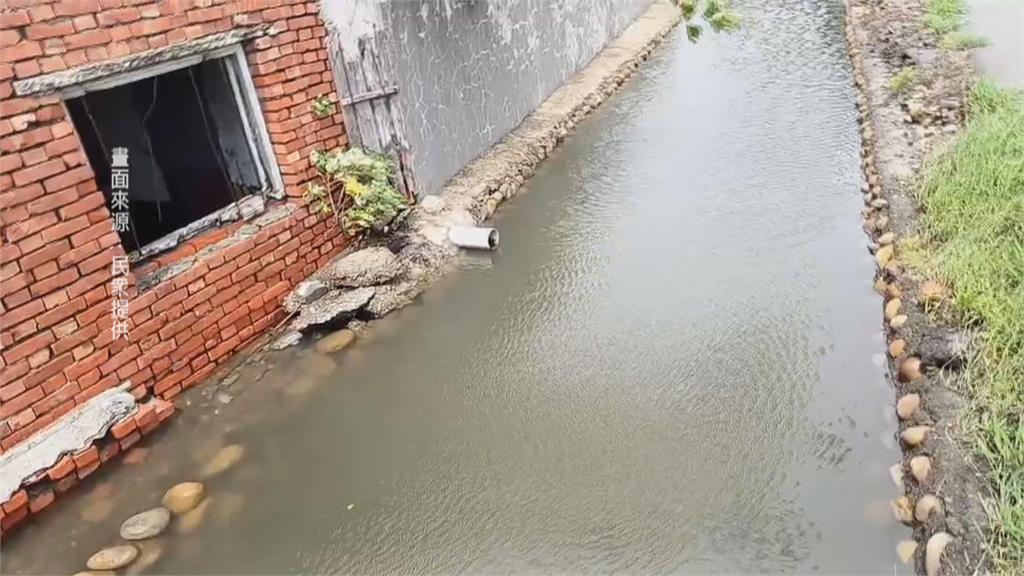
324 0 652 196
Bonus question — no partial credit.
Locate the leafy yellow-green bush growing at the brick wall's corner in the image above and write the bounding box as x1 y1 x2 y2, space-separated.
303 148 409 236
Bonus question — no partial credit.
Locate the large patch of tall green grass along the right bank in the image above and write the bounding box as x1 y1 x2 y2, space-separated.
909 80 1024 574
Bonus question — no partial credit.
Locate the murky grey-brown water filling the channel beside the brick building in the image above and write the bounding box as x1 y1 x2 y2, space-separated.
4 0 905 574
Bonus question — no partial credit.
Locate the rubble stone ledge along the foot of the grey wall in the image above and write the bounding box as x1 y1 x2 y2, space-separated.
271 0 680 342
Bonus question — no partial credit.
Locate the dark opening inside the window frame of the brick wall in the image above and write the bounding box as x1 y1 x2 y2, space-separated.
68 59 263 252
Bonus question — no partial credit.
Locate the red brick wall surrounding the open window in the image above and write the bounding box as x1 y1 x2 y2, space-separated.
0 0 346 452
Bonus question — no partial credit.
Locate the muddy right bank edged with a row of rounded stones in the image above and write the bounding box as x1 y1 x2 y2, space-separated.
847 0 988 576
